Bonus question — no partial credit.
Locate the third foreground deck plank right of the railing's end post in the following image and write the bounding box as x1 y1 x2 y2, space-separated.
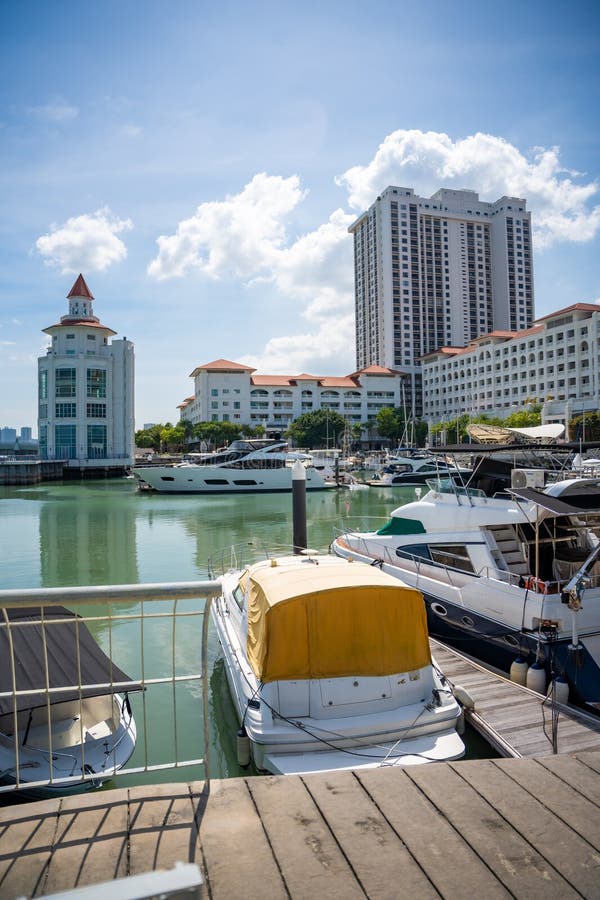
304 771 438 900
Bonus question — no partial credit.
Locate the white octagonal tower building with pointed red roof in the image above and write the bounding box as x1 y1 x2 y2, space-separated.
38 275 135 470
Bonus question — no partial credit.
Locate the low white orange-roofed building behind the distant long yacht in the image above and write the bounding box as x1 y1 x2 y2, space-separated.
179 359 404 431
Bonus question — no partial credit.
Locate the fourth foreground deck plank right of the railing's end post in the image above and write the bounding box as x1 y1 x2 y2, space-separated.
356 769 510 900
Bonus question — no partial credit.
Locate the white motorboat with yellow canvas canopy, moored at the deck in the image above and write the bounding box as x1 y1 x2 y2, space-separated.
212 555 465 774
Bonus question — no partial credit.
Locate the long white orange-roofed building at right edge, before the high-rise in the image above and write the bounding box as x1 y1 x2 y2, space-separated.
422 303 600 424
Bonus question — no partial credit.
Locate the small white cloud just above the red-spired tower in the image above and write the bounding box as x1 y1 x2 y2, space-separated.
35 207 133 273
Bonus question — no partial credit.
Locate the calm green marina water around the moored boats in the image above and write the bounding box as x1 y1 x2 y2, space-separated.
0 479 490 785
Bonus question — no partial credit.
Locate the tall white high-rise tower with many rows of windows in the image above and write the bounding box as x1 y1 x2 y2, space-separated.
348 187 534 415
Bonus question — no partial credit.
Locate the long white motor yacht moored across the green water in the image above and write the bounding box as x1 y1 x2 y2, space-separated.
133 439 333 494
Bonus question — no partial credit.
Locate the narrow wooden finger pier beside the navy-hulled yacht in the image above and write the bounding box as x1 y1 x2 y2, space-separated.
431 640 600 758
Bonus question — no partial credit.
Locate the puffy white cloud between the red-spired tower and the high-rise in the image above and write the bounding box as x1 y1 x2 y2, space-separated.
148 172 304 281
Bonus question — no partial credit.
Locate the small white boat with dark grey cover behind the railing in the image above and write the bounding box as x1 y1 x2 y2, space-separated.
0 607 140 799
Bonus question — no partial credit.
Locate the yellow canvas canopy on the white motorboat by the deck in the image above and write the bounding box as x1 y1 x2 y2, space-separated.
240 557 431 682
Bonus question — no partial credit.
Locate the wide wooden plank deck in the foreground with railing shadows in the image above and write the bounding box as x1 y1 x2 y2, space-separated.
0 752 600 900
